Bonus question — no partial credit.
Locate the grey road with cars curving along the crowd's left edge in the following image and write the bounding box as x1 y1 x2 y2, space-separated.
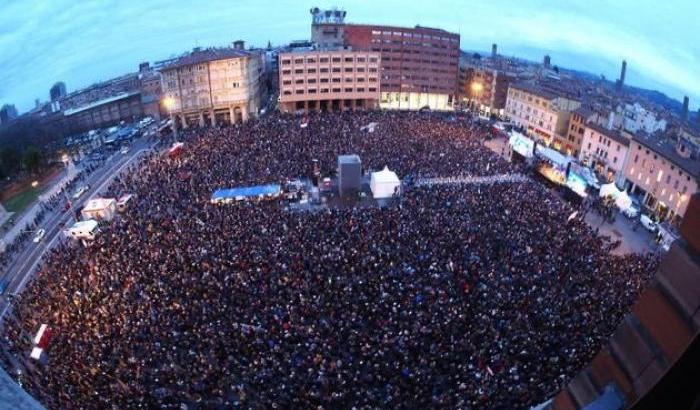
0 138 154 318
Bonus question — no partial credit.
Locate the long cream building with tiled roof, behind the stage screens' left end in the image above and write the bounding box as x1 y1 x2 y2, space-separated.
506 83 581 150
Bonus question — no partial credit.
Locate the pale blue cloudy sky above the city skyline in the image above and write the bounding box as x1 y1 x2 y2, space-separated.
0 0 700 112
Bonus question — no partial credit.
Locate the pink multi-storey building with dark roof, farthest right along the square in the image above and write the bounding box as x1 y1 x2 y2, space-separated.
624 133 700 224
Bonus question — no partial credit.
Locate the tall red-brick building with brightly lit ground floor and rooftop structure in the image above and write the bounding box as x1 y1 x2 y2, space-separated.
311 9 459 110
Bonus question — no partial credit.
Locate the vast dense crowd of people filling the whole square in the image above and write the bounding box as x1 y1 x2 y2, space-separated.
2 112 656 409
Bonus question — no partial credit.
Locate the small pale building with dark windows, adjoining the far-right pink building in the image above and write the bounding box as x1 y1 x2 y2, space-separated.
579 122 631 185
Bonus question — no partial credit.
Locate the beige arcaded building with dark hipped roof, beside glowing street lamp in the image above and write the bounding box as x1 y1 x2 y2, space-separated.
160 45 264 128
